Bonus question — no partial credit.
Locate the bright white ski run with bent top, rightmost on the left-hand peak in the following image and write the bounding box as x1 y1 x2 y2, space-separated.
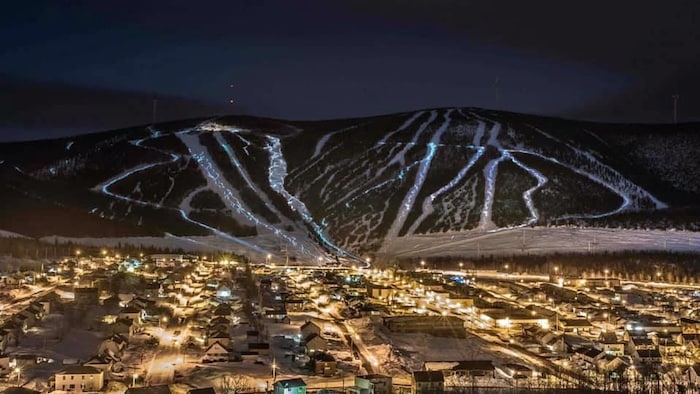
265 135 354 257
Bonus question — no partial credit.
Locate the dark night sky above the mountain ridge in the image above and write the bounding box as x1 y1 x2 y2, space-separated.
0 0 700 140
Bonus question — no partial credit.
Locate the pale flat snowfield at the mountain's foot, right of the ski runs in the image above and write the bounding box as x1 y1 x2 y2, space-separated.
384 227 700 258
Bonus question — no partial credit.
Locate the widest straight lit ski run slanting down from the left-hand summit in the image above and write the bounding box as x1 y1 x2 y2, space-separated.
179 134 314 255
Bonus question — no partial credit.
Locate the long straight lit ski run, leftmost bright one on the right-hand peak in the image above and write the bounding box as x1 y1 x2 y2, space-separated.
387 109 453 240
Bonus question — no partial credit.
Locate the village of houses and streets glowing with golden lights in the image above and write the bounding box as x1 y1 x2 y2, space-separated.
0 250 700 394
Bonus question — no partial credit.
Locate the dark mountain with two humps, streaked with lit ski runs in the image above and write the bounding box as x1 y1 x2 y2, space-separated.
0 108 700 257
